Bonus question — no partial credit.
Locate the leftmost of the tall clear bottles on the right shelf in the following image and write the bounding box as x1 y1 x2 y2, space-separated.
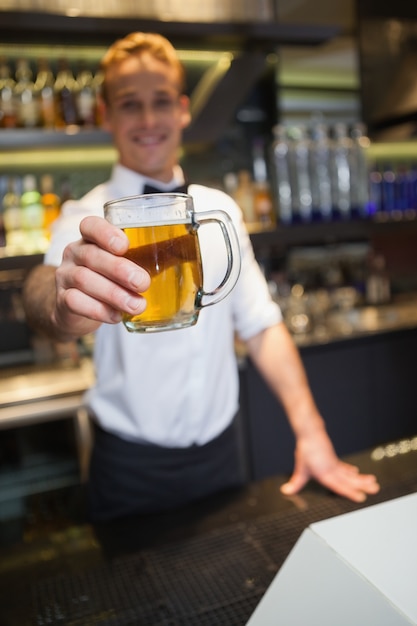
272 124 293 224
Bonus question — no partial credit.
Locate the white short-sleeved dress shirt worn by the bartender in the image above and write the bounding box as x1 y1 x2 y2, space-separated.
45 165 282 447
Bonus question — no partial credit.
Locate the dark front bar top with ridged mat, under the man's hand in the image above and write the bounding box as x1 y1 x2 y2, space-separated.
0 437 417 626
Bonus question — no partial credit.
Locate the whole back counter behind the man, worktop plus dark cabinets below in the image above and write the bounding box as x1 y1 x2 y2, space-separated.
0 294 417 520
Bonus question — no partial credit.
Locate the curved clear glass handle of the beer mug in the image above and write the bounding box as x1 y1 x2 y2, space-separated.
194 210 241 309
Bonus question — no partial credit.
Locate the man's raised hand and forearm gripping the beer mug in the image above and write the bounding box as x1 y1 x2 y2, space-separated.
23 217 150 341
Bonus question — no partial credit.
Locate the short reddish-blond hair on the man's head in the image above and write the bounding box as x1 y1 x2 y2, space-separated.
100 32 185 100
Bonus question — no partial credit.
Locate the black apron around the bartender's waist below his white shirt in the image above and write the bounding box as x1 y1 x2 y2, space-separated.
88 417 246 522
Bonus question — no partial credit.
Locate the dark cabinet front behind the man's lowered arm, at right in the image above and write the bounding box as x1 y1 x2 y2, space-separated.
241 329 417 479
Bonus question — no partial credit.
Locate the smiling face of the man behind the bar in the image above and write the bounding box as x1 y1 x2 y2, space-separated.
105 53 190 182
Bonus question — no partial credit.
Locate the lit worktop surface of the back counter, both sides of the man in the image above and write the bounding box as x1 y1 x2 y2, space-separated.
0 294 417 429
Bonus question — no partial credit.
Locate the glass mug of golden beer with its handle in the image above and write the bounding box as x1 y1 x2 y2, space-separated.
104 193 240 333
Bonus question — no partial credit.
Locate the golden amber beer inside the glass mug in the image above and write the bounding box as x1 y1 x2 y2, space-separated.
123 224 203 332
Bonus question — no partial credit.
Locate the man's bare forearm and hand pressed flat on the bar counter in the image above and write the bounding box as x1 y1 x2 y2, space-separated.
247 323 379 502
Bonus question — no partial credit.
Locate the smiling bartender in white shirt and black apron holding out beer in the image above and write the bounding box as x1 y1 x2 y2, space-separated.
23 33 379 521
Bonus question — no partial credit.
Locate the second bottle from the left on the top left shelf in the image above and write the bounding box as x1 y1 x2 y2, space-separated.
14 59 40 128
